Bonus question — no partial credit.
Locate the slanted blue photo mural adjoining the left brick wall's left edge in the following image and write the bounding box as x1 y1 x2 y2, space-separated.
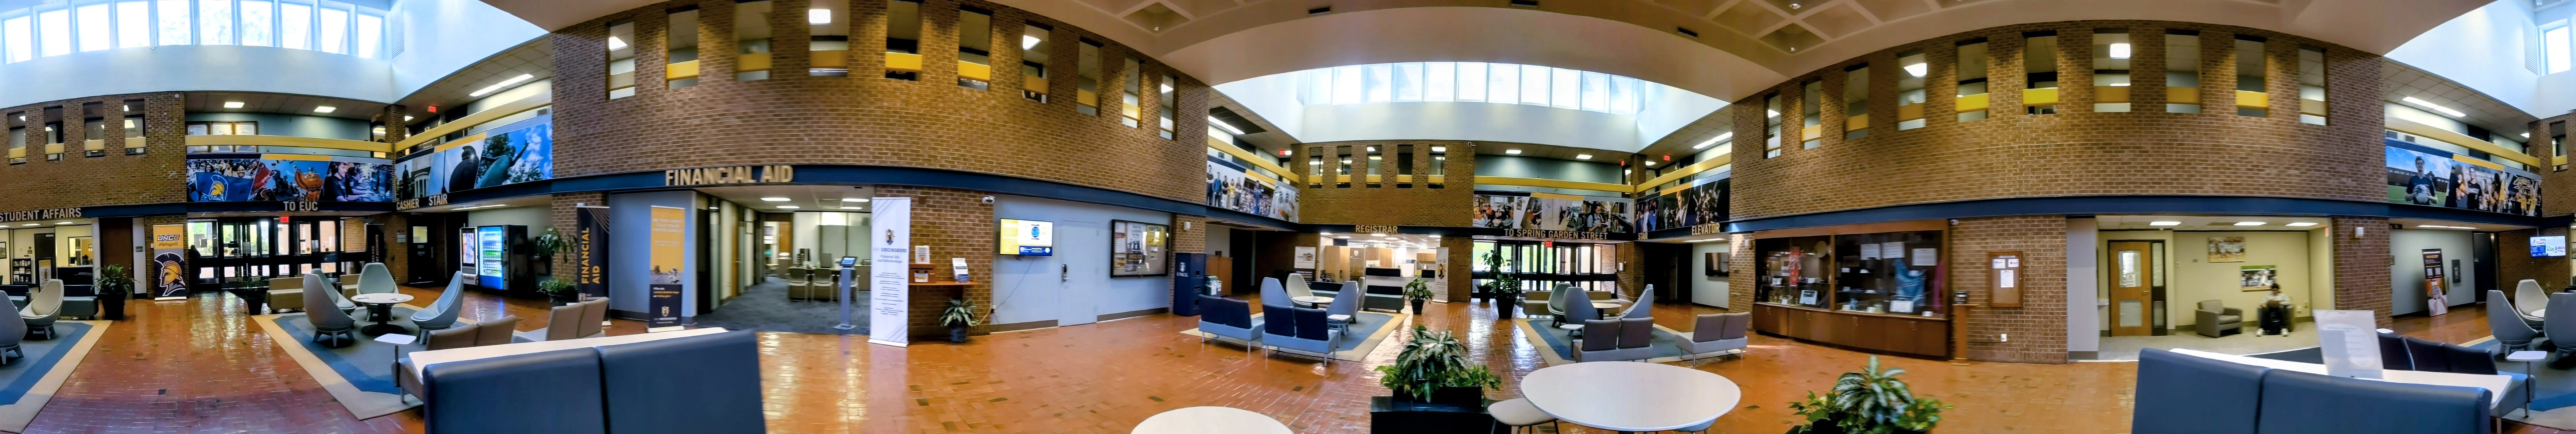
394 115 554 198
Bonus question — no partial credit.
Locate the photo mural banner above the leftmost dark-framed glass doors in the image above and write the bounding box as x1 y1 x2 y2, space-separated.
188 154 394 203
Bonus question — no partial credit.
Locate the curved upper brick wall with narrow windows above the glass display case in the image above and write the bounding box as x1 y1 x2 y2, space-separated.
1731 21 2386 218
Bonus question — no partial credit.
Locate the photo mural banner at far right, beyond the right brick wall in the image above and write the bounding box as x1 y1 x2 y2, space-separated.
2388 141 2540 216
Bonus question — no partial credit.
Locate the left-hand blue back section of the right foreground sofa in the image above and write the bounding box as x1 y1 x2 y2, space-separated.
2128 349 2267 434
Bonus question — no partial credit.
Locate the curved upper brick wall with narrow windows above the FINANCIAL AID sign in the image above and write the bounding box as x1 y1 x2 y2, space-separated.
549 0 1213 203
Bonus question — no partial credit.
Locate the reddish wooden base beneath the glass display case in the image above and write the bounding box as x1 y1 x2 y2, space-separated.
1754 303 1950 357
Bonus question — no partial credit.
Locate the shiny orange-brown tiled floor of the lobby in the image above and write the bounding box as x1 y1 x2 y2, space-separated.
28 287 2545 432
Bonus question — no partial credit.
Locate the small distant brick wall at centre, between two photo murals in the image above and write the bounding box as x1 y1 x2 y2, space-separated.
1288 141 1476 226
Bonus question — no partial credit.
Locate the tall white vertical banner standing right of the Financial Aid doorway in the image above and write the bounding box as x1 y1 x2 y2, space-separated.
868 198 912 347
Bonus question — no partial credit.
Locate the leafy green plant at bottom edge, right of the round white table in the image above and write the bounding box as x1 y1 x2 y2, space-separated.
1788 357 1950 434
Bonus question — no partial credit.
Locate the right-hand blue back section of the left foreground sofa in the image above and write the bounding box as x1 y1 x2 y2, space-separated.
598 331 768 434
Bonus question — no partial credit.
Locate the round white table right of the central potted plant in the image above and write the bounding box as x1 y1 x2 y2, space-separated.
1520 362 1744 432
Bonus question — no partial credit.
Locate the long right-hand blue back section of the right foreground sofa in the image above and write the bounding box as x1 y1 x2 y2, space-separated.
2267 370 2494 434
